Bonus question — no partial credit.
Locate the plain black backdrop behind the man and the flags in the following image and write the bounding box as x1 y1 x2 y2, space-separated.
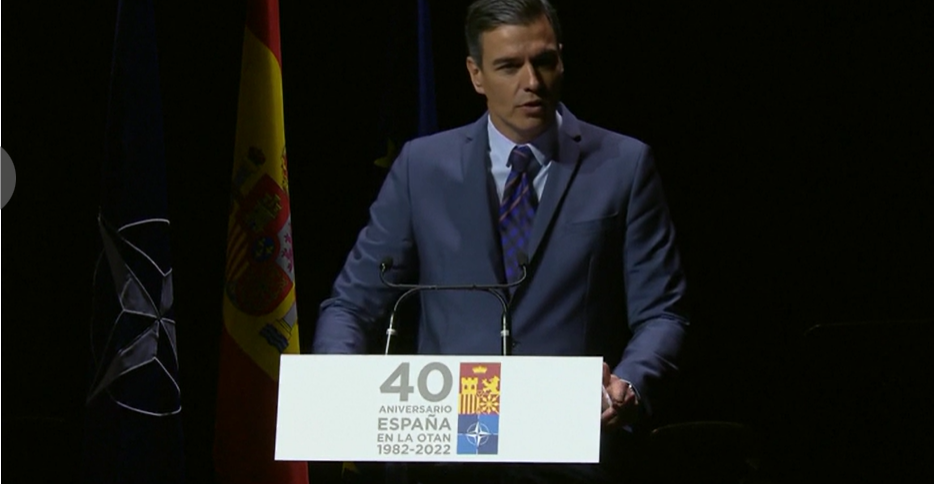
3 0 934 482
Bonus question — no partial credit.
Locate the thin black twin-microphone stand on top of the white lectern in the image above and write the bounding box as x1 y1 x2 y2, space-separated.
379 252 529 356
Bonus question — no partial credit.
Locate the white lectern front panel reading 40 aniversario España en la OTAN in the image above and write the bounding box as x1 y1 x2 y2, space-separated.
276 355 603 464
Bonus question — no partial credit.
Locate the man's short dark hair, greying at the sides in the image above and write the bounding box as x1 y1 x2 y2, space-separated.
464 0 561 65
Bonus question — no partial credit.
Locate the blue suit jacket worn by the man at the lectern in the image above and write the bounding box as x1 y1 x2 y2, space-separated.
314 105 688 411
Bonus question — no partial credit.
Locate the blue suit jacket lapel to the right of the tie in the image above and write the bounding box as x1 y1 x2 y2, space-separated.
529 105 580 261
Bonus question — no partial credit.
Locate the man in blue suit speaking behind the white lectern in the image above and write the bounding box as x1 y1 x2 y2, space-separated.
314 0 688 482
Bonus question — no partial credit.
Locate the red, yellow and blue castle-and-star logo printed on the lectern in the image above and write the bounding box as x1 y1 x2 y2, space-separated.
457 363 502 455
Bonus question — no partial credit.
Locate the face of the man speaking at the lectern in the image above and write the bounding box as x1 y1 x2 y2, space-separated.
467 16 564 143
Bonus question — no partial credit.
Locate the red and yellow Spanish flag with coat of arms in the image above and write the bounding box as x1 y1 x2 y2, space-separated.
214 0 308 484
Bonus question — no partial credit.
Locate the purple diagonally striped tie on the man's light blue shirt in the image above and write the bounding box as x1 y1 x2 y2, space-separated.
499 146 536 282
